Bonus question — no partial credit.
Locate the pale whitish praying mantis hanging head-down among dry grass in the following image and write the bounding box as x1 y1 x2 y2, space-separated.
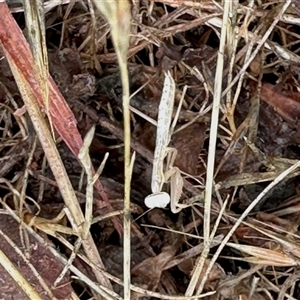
145 72 185 213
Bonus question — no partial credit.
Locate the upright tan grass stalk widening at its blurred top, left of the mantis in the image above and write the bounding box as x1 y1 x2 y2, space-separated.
94 0 132 299
